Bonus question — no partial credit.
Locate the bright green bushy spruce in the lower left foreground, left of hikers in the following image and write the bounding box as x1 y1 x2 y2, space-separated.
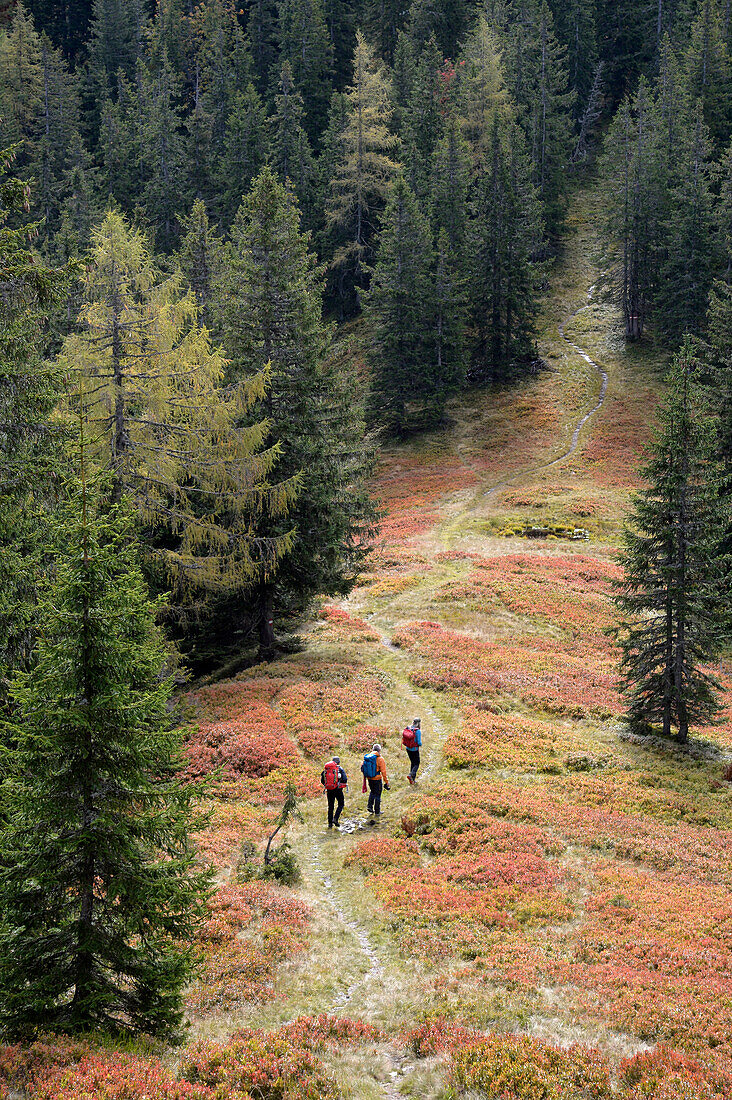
0 484 208 1035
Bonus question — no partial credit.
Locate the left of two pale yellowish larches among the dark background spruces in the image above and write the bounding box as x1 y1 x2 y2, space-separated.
327 34 398 309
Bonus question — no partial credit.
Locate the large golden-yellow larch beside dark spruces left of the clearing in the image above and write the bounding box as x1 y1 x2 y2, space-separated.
61 212 293 594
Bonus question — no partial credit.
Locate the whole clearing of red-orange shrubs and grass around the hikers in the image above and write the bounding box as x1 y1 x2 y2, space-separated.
5 187 732 1100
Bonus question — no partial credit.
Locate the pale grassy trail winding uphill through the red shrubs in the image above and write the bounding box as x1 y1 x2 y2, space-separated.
268 180 656 1097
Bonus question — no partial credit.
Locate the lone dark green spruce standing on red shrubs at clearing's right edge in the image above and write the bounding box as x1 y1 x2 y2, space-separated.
618 340 729 741
